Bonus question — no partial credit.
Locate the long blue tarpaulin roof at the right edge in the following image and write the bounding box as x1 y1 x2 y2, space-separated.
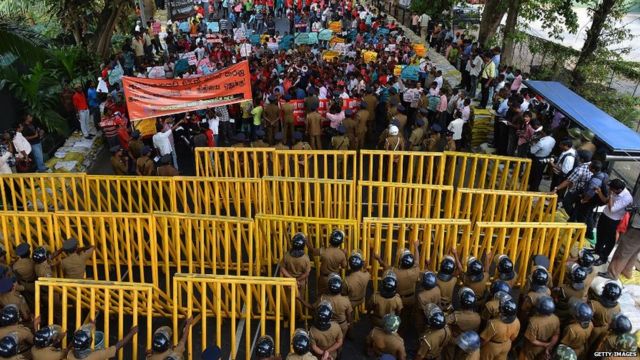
525 81 640 155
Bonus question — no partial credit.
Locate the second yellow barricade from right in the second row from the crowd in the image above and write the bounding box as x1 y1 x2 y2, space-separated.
358 181 453 219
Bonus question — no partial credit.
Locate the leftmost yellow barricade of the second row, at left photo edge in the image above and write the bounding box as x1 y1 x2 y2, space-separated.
0 173 86 211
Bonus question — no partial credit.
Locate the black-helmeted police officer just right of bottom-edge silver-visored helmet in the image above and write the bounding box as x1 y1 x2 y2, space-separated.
480 299 520 360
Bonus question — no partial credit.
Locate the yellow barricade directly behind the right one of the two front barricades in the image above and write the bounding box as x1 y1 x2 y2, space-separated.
153 213 260 289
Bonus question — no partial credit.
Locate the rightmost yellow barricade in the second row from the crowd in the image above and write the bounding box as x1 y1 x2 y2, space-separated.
452 188 558 223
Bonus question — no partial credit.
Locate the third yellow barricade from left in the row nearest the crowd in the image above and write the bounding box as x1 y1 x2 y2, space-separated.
358 150 444 185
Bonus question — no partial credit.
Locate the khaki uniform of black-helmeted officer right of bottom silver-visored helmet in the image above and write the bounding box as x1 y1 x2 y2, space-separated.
480 319 520 360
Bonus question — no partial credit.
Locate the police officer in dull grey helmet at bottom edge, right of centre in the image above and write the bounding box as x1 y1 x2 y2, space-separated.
367 314 407 360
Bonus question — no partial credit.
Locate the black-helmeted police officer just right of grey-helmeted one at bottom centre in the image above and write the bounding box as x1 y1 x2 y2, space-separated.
414 304 452 360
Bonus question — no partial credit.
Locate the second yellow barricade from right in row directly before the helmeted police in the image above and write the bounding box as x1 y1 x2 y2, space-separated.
362 218 474 287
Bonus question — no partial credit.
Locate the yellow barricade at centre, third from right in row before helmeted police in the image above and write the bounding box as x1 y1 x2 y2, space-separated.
256 214 365 276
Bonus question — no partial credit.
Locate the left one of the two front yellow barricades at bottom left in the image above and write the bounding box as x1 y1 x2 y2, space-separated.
35 278 154 360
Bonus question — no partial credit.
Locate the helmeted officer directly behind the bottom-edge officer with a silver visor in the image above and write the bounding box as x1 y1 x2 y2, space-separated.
445 287 481 359
